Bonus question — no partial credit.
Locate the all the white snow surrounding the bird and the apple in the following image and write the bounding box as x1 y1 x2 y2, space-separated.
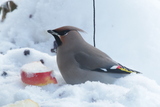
0 0 160 107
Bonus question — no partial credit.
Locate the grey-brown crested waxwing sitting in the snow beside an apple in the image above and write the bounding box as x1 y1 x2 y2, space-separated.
47 26 140 85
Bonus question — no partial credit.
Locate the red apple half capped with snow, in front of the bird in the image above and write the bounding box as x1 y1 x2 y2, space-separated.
21 61 57 86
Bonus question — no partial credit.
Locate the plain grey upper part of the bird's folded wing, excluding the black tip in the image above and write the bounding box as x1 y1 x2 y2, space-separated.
75 52 117 70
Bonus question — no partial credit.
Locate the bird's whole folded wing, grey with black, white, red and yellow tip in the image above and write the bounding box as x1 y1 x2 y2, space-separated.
75 52 140 74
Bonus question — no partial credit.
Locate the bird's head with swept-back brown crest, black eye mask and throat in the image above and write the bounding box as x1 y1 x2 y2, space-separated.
47 26 84 46
